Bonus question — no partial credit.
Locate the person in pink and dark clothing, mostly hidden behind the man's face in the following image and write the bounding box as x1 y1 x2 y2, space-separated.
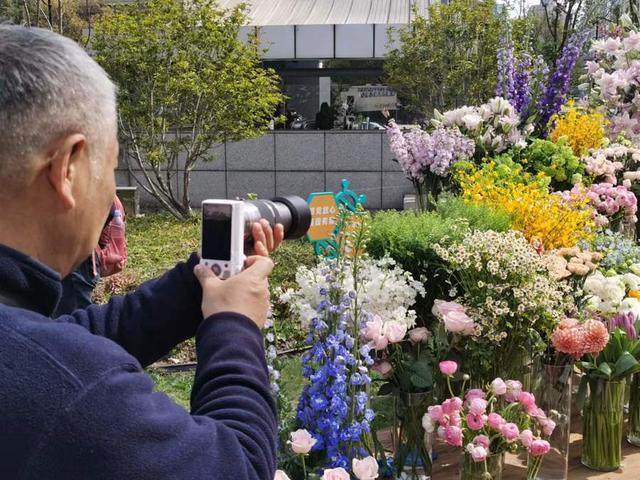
53 195 127 317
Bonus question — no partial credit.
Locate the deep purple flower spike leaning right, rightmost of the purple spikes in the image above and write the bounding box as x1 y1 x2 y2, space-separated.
537 34 587 130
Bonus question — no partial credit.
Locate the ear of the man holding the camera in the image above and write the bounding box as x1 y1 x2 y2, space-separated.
47 133 87 209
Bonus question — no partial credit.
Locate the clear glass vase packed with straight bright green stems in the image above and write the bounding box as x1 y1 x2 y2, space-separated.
581 378 626 471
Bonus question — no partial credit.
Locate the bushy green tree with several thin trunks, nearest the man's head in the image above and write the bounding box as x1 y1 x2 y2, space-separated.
92 0 282 218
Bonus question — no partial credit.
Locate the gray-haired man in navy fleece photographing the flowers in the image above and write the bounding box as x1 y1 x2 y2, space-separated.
0 26 282 480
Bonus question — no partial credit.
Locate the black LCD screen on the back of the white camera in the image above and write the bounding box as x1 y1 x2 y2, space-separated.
202 203 232 260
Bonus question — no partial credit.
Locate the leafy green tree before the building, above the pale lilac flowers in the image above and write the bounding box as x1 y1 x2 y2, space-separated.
385 0 504 114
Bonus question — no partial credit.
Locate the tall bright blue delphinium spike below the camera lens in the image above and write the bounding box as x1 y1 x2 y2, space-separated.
297 282 375 469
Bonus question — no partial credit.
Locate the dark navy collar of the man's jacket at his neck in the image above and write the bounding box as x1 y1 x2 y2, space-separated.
0 245 62 317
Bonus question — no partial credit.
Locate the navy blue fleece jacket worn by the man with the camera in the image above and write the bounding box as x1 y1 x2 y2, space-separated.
0 246 277 480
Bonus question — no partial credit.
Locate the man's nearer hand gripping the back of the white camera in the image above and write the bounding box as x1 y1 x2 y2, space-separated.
193 255 273 328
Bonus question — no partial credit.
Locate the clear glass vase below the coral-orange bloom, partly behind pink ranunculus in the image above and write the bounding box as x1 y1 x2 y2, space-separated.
527 360 573 480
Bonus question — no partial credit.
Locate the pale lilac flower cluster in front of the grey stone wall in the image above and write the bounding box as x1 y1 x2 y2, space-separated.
387 120 475 179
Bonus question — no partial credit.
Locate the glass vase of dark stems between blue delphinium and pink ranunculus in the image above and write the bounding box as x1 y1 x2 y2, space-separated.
393 392 433 480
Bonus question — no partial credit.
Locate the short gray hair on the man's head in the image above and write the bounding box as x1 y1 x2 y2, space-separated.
0 25 117 185
